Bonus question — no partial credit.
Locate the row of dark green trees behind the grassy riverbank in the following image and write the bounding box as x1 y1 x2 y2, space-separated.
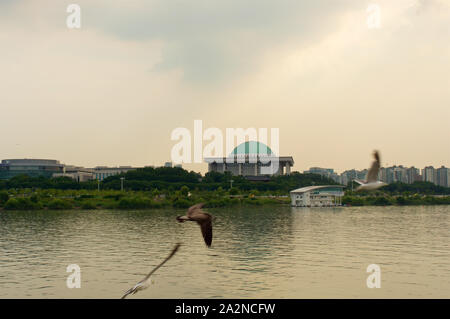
0 167 450 195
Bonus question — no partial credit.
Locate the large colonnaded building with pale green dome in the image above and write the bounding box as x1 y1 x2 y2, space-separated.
205 141 294 179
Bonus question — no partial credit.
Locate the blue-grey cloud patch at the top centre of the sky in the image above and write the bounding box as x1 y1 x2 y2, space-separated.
81 0 356 85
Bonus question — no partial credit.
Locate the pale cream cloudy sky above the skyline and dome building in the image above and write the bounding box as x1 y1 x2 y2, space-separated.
0 0 450 172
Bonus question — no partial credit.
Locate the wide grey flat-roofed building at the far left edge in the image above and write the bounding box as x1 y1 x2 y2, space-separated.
0 158 64 179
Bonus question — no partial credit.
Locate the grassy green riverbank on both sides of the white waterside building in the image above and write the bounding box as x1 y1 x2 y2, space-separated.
0 188 450 210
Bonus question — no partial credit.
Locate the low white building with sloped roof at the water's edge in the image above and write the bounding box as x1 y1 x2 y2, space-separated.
290 185 344 207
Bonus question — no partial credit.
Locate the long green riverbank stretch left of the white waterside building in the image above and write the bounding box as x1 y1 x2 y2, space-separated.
0 189 290 210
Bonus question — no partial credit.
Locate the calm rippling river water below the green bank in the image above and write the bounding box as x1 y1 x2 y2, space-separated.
0 206 450 298
